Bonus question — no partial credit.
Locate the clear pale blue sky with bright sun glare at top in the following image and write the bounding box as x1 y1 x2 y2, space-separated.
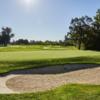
0 0 100 41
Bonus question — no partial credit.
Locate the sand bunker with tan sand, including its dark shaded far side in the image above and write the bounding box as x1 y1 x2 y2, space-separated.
0 64 100 94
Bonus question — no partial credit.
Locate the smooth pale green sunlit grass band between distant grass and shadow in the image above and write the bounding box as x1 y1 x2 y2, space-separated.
0 49 100 61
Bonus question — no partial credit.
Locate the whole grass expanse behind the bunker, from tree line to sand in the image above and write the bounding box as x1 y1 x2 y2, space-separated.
0 46 100 73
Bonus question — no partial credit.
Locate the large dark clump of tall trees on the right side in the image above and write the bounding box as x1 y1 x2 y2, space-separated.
65 9 100 50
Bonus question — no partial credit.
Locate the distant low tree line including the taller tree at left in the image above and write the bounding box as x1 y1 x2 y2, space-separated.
0 27 72 46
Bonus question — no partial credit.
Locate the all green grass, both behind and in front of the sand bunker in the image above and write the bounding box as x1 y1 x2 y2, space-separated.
0 46 100 100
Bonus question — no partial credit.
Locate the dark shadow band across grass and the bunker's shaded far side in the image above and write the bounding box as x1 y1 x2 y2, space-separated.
0 56 100 77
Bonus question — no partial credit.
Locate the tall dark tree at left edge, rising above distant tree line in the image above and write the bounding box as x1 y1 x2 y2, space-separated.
0 27 14 46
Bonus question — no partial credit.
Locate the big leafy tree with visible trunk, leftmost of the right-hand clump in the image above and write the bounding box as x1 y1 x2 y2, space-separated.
68 16 93 49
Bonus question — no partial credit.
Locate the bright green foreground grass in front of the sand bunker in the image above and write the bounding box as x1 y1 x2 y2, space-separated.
0 84 100 100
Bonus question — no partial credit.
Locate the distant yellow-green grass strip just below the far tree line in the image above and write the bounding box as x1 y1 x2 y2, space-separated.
0 45 77 52
